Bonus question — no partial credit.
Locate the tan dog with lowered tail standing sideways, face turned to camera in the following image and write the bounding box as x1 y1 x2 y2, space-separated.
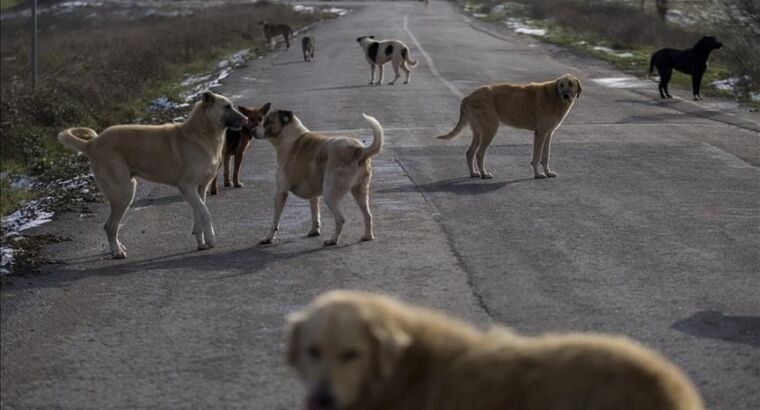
438 74 583 179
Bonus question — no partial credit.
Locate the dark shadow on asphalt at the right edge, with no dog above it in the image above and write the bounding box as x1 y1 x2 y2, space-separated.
671 310 760 347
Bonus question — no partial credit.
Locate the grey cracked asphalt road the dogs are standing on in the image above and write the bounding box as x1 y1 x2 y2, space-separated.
0 2 760 409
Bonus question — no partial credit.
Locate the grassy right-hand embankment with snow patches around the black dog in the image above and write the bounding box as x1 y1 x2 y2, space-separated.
465 0 760 108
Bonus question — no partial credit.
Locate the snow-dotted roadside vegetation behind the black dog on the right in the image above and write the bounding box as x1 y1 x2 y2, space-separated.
464 0 760 105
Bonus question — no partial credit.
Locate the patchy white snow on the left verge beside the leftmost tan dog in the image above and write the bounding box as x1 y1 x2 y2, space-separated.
0 175 92 275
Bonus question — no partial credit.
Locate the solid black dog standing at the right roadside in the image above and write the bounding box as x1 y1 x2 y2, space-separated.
649 36 723 100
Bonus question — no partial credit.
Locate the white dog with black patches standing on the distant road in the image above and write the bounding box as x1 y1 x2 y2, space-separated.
356 36 417 85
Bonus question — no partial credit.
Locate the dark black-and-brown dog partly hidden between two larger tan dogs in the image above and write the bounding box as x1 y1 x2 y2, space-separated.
209 103 270 195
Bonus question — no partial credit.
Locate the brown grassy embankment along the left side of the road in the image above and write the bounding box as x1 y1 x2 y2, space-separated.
0 0 320 215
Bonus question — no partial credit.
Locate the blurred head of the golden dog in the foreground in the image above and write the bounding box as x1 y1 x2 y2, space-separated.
288 291 411 410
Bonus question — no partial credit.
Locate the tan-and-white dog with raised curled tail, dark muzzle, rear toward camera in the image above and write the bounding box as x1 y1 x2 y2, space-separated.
253 110 383 246
